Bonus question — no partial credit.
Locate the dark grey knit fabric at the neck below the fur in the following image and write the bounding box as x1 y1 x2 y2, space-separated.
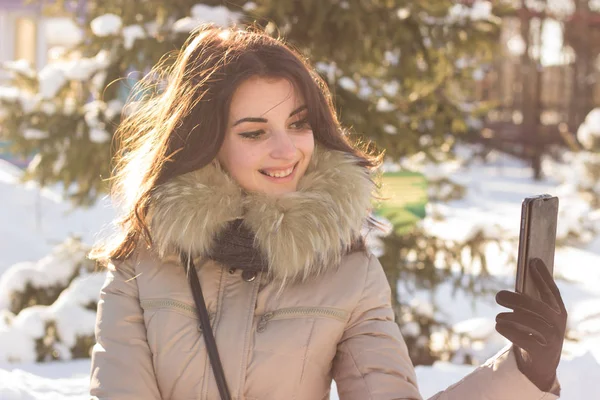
208 218 267 272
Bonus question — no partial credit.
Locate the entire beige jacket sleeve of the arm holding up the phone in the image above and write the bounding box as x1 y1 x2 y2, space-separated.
333 254 560 400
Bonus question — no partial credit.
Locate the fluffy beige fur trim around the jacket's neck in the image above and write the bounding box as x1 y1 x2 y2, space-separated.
149 145 375 282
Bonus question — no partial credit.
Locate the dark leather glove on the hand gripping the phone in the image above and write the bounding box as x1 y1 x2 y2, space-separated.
496 259 567 392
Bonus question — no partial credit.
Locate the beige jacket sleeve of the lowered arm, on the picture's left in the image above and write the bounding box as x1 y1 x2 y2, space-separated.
90 260 161 400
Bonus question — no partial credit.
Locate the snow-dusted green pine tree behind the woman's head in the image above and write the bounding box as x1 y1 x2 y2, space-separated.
0 0 510 364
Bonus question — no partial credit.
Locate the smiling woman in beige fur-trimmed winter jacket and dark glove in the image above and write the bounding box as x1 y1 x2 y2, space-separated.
91 28 566 400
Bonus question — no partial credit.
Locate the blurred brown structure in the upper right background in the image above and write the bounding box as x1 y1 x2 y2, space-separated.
474 0 600 177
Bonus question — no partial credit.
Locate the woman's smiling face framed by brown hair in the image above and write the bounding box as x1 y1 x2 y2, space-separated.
217 77 315 195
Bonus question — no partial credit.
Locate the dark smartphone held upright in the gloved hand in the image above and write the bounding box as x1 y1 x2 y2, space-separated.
515 194 558 300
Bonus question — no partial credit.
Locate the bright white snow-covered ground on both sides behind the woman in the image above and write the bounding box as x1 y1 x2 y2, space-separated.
0 148 600 400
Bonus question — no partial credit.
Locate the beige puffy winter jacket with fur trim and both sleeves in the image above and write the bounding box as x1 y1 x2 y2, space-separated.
90 145 557 400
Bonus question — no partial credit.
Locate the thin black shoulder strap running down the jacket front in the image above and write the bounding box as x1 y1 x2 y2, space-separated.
181 253 231 400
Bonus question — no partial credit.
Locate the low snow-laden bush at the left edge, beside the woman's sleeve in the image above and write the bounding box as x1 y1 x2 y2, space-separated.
0 239 105 362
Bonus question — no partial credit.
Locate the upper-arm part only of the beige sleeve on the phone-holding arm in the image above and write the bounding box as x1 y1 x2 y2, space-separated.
333 254 421 400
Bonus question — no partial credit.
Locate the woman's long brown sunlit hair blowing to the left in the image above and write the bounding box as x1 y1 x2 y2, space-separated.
90 25 383 261
